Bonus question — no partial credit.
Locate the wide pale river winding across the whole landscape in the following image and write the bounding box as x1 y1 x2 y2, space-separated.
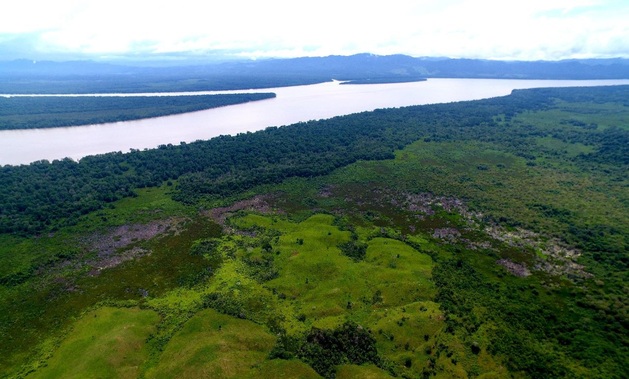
0 79 629 165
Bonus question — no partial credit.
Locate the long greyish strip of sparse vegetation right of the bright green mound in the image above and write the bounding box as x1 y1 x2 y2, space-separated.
332 188 592 279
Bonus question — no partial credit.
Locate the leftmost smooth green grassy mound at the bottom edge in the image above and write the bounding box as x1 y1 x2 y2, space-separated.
28 307 159 379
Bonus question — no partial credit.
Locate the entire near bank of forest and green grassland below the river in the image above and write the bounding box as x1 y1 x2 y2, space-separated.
0 86 629 378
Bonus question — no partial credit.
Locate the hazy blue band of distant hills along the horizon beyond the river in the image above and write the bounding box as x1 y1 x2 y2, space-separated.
0 54 629 93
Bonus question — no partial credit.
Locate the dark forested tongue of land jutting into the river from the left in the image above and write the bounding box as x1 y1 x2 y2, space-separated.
0 93 275 130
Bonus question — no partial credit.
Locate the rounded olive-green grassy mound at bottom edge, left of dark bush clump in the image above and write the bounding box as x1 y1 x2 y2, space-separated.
146 309 275 378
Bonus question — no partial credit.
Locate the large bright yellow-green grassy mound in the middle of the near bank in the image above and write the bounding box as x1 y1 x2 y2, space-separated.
232 214 435 336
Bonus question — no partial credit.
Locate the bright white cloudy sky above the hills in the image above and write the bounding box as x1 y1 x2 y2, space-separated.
0 0 629 60
